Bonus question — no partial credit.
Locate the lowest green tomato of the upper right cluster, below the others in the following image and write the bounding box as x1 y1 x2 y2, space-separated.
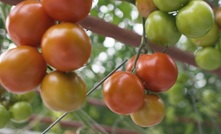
195 47 221 70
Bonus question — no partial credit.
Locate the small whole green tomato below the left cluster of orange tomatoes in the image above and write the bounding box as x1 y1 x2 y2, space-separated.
9 101 32 123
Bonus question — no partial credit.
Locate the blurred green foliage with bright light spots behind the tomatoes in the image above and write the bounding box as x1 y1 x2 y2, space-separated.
0 0 221 134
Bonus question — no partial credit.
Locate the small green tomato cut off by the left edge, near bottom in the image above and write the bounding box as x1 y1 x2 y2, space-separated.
0 104 10 128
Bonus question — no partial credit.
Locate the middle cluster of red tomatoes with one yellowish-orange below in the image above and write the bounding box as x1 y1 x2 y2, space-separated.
103 52 178 127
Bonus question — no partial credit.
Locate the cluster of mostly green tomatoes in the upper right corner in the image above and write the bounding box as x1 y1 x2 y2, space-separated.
136 0 221 70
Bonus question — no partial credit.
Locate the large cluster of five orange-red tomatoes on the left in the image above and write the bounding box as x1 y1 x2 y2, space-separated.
0 0 92 116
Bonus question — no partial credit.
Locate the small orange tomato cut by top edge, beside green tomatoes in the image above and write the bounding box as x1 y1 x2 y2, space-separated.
135 0 157 17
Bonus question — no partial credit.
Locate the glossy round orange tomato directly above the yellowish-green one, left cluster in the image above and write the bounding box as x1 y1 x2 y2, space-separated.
41 23 91 71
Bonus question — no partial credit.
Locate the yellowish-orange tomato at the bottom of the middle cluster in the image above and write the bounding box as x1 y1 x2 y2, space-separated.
130 94 165 127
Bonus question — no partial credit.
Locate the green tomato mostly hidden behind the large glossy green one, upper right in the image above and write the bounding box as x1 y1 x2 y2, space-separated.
190 24 219 47
